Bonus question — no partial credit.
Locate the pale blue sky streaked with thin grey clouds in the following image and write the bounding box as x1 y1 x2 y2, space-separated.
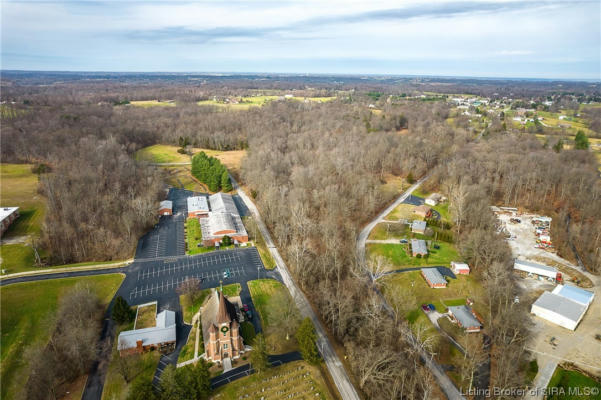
0 0 601 80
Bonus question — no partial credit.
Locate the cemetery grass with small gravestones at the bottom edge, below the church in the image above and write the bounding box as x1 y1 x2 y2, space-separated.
212 361 333 400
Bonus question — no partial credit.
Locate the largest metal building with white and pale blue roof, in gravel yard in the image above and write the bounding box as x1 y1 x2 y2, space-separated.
530 285 594 331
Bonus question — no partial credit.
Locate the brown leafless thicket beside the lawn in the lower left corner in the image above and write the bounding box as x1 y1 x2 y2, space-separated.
18 284 104 400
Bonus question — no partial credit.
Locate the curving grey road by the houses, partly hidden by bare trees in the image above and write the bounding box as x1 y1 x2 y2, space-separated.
357 175 465 400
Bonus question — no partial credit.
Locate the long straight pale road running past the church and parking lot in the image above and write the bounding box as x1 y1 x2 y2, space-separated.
230 176 359 400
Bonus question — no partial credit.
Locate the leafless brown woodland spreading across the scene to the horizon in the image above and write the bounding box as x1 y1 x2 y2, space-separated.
1 75 601 399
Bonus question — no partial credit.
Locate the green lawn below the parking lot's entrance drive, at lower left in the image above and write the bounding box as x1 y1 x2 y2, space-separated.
0 274 123 398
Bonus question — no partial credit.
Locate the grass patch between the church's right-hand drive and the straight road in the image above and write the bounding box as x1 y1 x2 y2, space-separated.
248 279 298 354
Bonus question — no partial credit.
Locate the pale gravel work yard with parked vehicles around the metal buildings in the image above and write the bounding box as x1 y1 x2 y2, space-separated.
496 210 601 387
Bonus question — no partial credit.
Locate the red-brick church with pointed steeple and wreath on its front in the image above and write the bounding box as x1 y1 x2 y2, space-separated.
203 290 246 363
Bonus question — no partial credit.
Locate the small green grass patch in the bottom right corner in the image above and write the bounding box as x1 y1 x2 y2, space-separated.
547 367 601 400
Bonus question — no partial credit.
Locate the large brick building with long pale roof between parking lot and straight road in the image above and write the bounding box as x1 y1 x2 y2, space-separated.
200 193 248 246
